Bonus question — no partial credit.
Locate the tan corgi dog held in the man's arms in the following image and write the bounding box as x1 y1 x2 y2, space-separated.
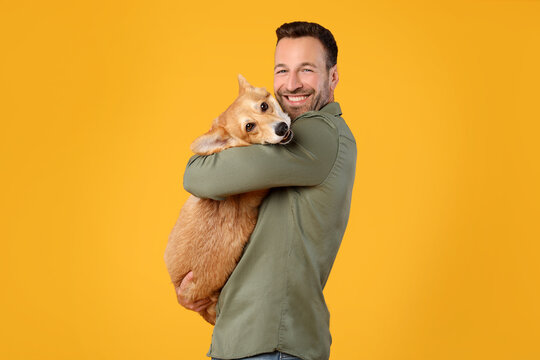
164 75 292 325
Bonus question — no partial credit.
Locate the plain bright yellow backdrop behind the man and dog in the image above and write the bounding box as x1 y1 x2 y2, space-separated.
0 0 540 360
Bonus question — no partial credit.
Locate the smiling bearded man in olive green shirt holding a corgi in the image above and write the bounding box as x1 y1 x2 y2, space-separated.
177 22 356 360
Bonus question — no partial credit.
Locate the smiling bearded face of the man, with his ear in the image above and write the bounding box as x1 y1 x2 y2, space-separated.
274 36 338 119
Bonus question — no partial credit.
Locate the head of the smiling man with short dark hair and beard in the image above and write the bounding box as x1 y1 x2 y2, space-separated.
274 21 339 119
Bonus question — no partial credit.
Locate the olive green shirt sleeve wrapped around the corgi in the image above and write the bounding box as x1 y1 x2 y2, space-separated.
184 115 339 200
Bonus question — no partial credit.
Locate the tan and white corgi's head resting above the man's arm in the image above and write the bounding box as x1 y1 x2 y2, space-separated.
191 75 292 155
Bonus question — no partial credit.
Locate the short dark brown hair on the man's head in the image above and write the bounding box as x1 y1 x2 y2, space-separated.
276 21 337 70
